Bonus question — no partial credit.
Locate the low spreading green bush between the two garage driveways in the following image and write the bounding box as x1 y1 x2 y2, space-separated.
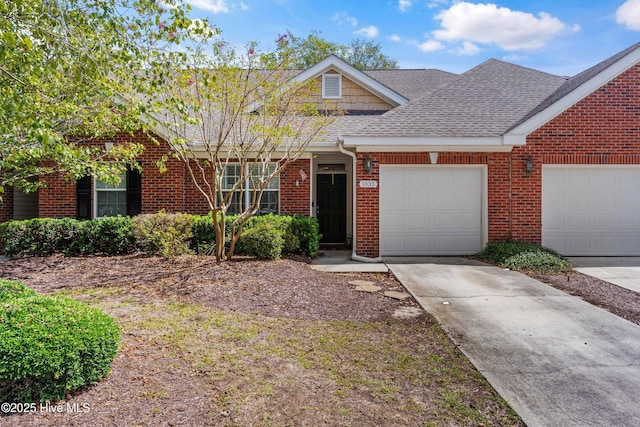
475 241 573 273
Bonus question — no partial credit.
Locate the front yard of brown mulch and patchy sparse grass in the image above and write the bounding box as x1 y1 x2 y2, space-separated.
0 255 522 426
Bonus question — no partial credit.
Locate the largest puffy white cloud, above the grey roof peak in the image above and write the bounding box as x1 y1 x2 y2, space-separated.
433 0 572 51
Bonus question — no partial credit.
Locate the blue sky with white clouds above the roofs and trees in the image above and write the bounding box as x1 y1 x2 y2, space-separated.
186 0 640 76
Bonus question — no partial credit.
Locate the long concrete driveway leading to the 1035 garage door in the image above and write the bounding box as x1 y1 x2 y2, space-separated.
385 257 640 426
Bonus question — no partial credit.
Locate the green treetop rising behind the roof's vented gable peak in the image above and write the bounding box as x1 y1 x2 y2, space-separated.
278 31 398 70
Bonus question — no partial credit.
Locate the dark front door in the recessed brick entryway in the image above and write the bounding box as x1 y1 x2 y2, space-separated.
316 174 347 243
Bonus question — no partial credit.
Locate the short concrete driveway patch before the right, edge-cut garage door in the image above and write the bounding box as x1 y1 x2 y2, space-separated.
569 257 640 292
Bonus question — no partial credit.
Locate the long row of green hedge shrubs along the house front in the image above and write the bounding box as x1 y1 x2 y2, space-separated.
0 212 320 258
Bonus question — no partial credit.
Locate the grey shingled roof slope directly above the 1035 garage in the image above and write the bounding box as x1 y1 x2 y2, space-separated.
345 59 567 137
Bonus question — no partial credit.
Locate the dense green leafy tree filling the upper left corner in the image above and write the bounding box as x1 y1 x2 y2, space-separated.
0 0 191 196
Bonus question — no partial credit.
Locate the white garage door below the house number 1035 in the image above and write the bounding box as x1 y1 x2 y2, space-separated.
380 165 484 255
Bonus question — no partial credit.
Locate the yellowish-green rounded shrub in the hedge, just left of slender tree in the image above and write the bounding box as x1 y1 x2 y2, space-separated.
132 211 193 258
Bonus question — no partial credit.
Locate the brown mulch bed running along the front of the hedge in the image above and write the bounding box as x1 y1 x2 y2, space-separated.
0 255 416 320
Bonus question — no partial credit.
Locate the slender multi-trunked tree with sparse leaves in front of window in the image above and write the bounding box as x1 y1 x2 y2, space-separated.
149 36 334 261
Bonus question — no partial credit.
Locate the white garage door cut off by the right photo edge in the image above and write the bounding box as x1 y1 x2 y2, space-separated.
542 166 640 255
